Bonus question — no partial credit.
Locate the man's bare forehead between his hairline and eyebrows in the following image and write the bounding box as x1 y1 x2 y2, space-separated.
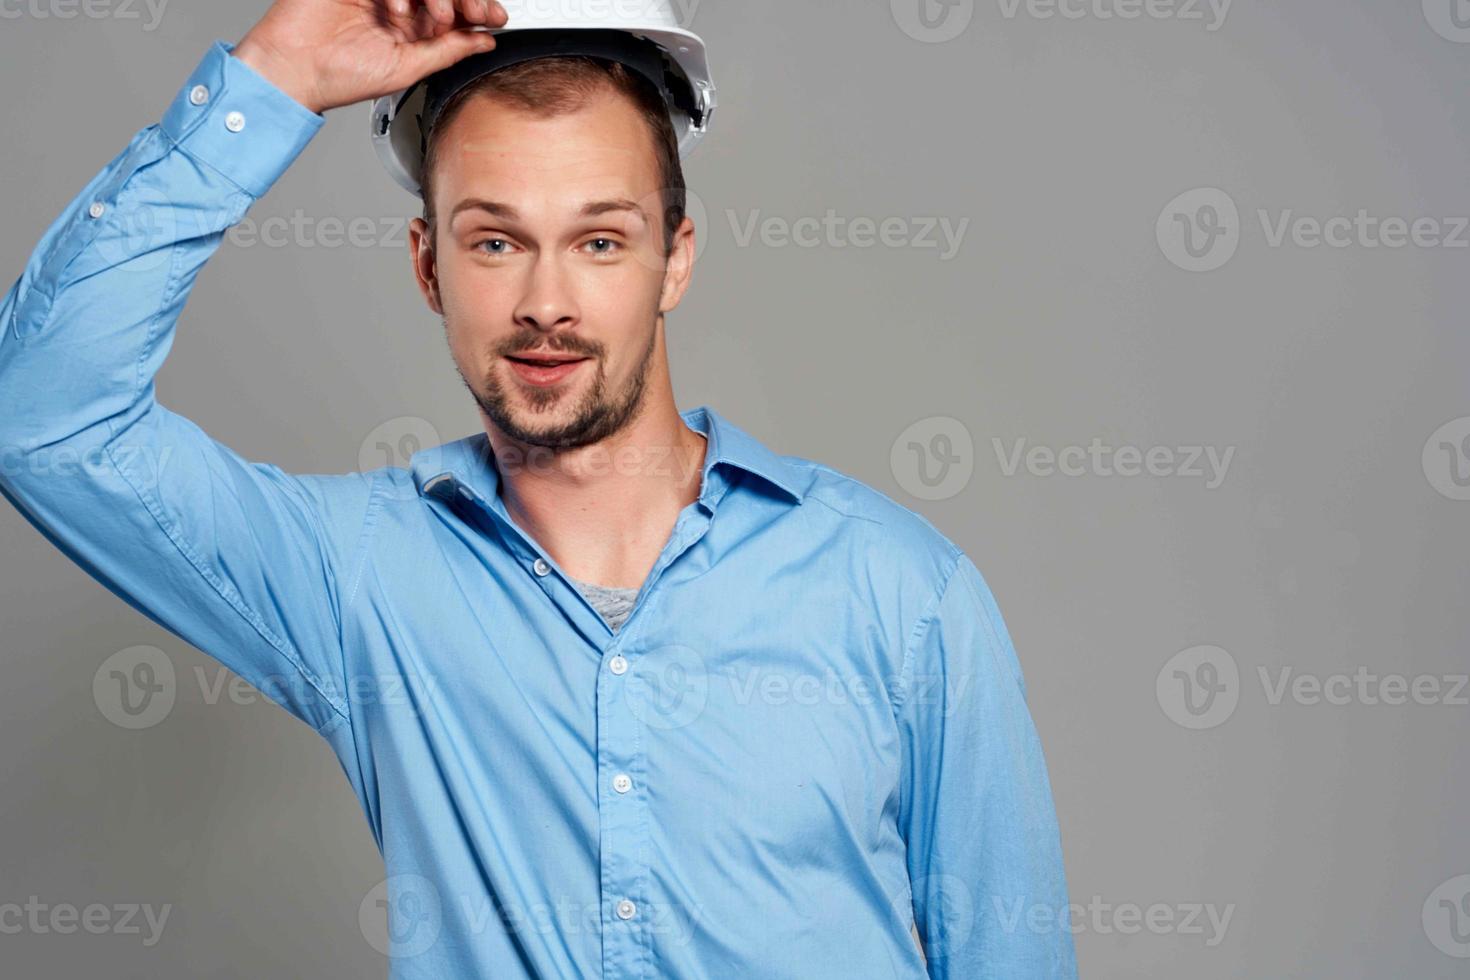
432 87 659 216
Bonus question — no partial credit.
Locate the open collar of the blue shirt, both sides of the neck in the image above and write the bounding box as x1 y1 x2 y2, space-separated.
409 406 807 513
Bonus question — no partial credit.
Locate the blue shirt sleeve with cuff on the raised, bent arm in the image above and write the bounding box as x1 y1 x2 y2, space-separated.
0 41 372 733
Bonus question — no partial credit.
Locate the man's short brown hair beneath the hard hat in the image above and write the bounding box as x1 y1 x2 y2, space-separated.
419 54 685 259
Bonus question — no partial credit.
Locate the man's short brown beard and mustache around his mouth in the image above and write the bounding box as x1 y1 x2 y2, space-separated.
456 331 659 450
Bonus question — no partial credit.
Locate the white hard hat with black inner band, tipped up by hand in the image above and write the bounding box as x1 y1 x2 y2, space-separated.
372 0 714 197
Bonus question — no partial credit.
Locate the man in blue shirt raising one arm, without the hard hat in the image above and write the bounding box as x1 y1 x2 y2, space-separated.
0 0 1076 980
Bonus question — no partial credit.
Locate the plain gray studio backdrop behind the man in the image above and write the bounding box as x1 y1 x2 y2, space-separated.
0 0 1470 980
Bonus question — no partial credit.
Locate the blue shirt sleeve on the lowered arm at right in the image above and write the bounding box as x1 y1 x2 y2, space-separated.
898 554 1076 980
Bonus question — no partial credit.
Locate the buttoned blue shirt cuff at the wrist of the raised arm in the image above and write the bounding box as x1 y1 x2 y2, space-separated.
162 41 326 198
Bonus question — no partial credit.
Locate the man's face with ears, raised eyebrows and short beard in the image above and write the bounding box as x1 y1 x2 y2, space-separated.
412 88 694 448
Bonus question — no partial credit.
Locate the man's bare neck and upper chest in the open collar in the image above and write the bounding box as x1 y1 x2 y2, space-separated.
487 397 707 588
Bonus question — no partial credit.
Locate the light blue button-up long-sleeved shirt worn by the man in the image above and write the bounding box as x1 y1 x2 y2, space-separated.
0 43 1076 980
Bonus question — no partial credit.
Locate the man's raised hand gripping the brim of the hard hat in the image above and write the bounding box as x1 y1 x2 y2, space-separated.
234 0 507 113
